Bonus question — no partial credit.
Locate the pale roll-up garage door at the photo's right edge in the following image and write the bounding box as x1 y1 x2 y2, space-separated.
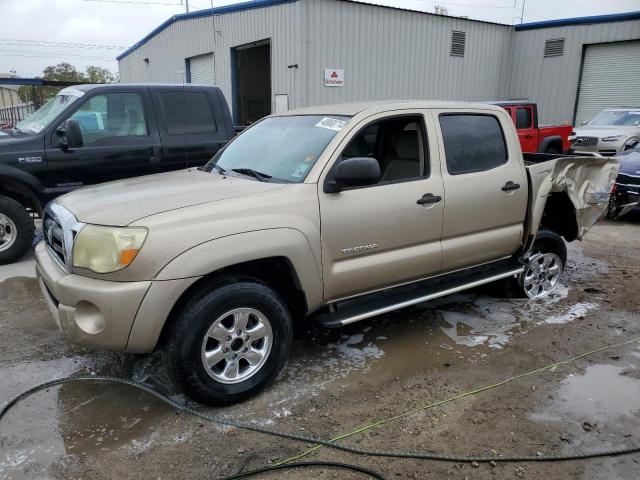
576 41 640 125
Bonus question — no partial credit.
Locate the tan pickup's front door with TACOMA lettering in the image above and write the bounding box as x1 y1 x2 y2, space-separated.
318 111 444 301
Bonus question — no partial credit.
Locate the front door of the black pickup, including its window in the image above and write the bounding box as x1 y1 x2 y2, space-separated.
46 91 162 193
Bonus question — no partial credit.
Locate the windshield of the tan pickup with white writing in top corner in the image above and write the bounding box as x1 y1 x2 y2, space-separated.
205 115 349 183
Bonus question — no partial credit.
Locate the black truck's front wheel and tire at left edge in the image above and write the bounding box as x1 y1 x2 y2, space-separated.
0 195 35 265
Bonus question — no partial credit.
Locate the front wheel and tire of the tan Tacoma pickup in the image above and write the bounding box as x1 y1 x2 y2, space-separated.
163 278 293 405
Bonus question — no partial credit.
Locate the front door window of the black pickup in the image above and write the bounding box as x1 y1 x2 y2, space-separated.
71 93 149 144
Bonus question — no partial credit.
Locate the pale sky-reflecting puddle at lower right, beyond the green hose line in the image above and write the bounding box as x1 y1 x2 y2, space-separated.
532 360 640 424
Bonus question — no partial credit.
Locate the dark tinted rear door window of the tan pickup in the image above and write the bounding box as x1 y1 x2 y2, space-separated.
440 114 508 175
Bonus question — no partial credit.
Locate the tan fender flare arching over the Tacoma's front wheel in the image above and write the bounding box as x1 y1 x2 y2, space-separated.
154 228 323 310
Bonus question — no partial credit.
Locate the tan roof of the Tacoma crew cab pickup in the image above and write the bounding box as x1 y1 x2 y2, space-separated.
274 100 501 117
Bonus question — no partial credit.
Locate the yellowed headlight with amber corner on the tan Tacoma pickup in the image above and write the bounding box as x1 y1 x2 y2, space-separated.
73 225 147 273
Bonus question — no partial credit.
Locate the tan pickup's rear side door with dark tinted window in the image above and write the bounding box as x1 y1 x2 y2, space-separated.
434 109 528 271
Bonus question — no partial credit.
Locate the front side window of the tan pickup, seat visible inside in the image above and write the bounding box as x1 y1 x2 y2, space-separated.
342 116 429 182
